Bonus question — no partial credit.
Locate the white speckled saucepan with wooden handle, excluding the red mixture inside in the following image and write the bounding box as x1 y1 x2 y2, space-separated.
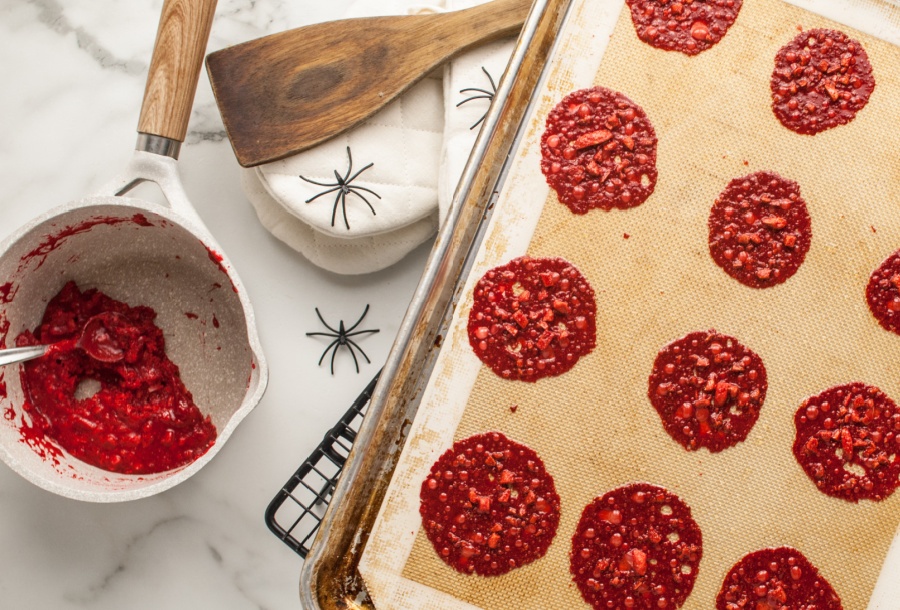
0 0 268 502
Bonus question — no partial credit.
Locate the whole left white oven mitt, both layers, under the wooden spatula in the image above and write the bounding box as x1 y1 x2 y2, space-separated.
241 0 443 275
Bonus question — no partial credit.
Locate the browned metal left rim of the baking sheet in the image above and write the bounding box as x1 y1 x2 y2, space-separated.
300 0 571 610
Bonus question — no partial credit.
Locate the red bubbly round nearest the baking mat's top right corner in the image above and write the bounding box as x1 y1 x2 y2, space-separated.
770 29 875 135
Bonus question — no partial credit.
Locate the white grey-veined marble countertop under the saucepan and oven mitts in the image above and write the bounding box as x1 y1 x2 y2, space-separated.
0 0 429 610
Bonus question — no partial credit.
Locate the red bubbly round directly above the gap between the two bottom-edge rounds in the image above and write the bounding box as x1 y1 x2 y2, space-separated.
647 330 768 453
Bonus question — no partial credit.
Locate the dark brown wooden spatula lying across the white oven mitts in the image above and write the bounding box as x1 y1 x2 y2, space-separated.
206 0 531 167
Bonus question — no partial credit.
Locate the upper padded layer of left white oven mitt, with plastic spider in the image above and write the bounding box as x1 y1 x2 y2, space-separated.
256 78 443 239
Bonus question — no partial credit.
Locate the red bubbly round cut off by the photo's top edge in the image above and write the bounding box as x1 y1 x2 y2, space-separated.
627 0 743 55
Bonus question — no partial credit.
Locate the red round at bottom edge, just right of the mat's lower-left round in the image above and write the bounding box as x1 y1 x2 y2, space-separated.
569 483 703 610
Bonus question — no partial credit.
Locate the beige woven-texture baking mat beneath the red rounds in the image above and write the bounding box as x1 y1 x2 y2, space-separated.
360 0 900 610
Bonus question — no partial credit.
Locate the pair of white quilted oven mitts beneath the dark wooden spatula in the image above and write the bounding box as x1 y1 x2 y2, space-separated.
241 0 513 275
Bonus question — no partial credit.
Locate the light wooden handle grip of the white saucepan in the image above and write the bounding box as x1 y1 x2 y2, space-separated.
138 0 217 142
